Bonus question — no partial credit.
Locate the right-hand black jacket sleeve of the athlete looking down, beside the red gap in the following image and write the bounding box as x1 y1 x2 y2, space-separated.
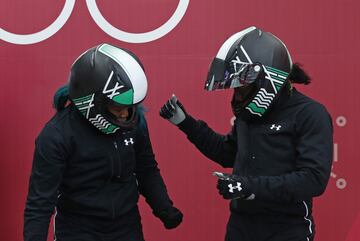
135 118 173 213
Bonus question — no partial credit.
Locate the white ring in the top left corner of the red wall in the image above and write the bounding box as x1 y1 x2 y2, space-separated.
0 0 75 44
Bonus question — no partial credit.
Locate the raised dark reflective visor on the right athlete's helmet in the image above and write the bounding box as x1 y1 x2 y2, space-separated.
205 59 264 91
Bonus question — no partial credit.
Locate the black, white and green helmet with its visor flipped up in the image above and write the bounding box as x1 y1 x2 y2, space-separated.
205 27 292 120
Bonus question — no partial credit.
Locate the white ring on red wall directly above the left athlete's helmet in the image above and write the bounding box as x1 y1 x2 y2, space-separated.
86 0 190 43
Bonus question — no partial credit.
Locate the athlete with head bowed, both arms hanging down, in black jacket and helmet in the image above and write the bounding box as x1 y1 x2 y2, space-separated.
24 44 182 241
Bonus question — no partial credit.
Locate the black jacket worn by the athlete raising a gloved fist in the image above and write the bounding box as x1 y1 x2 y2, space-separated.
179 89 333 217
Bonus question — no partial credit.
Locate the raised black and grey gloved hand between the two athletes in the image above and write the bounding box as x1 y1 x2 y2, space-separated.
160 94 187 125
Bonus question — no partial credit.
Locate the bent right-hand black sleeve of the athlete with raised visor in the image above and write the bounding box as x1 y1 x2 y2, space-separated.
249 103 333 201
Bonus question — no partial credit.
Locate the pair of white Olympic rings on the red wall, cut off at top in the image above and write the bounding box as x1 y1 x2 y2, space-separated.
0 0 190 44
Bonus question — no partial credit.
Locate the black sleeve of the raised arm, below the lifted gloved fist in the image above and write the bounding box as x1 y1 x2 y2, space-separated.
178 115 237 167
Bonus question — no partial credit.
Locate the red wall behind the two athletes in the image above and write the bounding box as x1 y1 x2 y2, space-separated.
0 0 360 241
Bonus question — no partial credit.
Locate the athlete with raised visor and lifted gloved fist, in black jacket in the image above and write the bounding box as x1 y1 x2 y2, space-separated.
160 27 333 241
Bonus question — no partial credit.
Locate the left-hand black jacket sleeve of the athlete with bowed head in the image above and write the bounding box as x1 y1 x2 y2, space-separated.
23 125 66 241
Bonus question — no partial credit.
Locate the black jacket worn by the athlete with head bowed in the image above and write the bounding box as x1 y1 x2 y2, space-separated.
24 105 172 241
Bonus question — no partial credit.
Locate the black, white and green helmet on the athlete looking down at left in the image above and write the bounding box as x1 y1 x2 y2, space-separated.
69 44 147 134
